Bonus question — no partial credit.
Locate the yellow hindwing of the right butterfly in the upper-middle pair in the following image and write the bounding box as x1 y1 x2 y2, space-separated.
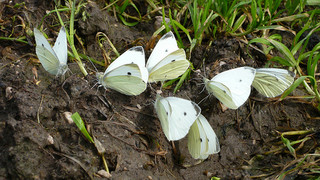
148 49 190 82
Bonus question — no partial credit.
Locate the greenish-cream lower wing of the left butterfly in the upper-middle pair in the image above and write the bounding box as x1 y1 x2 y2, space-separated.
98 64 147 96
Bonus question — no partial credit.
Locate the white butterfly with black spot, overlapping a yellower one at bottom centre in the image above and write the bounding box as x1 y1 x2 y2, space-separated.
154 95 201 141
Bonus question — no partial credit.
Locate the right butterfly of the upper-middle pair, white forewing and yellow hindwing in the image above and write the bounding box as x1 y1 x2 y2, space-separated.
147 31 190 82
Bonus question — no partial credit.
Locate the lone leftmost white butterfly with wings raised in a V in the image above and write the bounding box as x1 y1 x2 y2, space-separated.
34 27 68 76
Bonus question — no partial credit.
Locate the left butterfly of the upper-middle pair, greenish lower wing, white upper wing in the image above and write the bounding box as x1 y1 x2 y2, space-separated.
96 46 148 96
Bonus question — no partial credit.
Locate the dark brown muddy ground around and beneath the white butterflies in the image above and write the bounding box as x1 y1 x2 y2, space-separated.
0 1 320 179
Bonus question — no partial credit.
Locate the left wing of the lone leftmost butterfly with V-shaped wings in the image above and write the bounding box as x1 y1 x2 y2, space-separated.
34 28 60 75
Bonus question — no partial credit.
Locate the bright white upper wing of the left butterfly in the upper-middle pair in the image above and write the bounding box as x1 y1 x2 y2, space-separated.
104 46 149 82
